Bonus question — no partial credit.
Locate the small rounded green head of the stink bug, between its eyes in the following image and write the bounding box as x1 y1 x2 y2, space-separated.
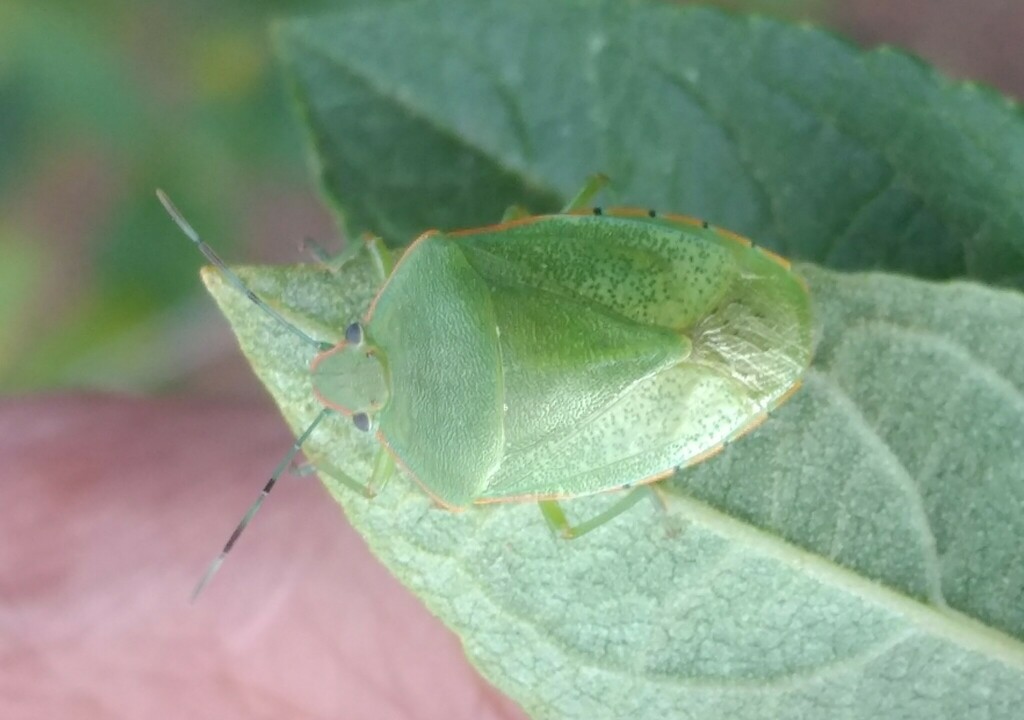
309 341 391 416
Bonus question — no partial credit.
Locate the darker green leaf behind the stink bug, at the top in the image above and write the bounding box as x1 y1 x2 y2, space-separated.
278 0 1024 286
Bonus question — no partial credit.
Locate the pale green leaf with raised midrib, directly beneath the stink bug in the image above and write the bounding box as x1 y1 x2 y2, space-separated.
205 258 1024 720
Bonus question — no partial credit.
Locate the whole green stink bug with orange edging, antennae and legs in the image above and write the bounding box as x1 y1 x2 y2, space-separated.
158 176 811 593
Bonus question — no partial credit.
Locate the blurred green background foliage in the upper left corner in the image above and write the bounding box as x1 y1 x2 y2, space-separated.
0 0 321 390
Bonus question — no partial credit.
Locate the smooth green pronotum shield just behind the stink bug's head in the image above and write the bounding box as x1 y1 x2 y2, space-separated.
367 236 504 507
